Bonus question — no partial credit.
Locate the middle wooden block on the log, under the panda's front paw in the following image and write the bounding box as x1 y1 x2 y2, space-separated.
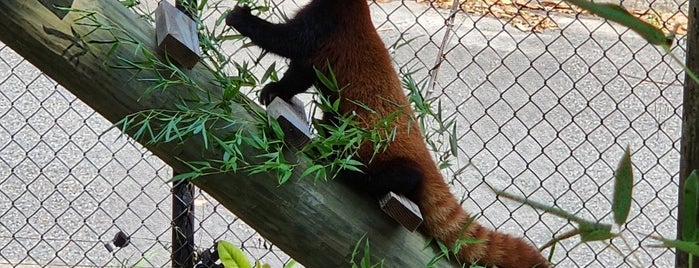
267 97 311 149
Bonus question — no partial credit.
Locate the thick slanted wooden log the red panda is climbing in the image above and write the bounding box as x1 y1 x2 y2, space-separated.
0 0 456 267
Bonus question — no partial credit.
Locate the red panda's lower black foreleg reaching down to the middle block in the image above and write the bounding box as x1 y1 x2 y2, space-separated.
260 60 315 105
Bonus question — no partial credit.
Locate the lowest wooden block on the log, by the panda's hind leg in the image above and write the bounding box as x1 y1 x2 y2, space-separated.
379 192 422 232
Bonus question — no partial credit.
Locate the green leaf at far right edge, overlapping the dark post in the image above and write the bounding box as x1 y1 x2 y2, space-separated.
680 170 699 242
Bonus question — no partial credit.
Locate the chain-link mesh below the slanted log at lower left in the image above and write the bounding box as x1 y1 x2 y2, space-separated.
0 45 289 267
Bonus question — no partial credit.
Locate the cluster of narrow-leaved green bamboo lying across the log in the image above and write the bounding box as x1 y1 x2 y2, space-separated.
71 1 408 184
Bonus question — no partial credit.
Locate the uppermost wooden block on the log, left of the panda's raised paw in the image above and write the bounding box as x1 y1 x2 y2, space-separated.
155 0 201 69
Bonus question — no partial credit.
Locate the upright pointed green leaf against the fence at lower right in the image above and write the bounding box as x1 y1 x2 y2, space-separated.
612 146 633 225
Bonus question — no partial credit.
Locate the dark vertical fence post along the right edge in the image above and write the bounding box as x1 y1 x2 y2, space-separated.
675 1 699 268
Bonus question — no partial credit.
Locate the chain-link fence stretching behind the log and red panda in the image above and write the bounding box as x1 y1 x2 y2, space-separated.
0 0 687 267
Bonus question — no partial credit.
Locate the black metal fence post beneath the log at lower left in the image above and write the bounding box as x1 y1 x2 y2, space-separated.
171 175 194 268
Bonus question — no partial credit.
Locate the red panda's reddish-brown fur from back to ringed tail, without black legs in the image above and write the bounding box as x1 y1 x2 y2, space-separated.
229 0 549 268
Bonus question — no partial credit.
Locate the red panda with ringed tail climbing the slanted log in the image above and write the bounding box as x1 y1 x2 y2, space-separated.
226 0 549 268
